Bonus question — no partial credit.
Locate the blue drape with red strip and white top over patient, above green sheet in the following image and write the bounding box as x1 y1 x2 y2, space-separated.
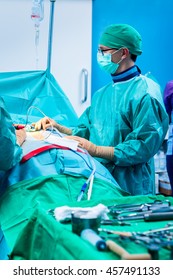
1 130 124 192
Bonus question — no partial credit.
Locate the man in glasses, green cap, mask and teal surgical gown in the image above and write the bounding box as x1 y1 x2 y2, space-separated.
35 24 168 195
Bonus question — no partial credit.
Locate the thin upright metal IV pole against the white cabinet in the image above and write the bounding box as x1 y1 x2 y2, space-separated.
47 0 56 75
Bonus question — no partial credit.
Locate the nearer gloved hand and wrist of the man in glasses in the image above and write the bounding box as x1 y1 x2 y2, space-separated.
66 136 114 160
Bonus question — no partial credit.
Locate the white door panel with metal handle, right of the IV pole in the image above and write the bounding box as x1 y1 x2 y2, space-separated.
52 0 92 115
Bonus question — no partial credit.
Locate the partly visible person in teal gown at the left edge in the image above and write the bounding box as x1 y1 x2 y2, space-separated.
0 97 26 171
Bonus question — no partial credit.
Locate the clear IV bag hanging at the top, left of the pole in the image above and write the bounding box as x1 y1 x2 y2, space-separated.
31 0 44 27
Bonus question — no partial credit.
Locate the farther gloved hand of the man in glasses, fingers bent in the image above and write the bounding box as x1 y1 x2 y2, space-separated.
32 117 72 135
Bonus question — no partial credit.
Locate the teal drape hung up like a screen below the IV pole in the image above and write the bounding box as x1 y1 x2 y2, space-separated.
0 70 77 126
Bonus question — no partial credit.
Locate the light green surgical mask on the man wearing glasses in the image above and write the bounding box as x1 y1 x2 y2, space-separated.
97 50 121 74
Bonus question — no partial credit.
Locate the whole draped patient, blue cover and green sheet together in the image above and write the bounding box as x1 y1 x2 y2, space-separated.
0 124 128 252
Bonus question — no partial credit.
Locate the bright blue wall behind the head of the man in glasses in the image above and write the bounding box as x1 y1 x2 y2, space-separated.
92 0 173 93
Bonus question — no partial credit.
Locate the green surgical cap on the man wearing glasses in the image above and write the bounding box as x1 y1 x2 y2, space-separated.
99 24 142 55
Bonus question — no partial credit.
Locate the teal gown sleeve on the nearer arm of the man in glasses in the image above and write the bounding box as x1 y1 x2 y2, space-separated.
114 95 168 166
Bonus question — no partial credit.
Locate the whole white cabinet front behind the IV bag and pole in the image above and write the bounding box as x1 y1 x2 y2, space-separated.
0 0 92 115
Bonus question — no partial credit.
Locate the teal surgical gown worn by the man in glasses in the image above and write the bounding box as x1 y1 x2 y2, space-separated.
73 75 168 195
